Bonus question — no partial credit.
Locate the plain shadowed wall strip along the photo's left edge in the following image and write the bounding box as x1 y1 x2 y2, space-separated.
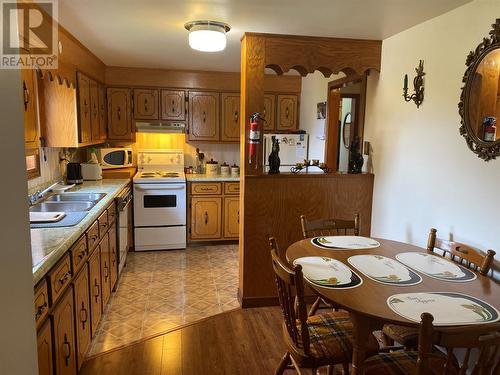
0 69 38 374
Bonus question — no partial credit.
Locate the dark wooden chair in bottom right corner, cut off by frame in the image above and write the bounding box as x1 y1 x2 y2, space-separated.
363 313 500 375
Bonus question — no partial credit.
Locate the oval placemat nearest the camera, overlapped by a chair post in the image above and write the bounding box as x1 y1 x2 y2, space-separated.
387 292 499 326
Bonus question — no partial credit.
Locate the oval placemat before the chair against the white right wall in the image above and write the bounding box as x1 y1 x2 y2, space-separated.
396 252 477 282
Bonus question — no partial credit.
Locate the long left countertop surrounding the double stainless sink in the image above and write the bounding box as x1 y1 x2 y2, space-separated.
31 179 130 284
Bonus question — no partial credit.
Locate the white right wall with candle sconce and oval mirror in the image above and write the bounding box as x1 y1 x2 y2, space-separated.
365 0 500 268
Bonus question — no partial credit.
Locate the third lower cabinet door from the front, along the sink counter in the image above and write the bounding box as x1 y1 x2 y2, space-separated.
73 264 91 368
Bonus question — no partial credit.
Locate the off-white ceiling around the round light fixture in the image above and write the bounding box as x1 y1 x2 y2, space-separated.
59 0 470 71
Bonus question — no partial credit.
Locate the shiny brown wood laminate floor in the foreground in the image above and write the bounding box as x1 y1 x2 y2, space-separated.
81 307 346 375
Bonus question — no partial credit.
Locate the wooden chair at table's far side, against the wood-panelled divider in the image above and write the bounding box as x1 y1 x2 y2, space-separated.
300 214 359 315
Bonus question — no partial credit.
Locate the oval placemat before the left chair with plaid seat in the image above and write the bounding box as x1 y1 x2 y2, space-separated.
293 257 363 289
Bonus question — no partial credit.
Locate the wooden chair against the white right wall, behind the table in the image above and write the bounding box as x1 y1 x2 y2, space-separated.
382 228 500 352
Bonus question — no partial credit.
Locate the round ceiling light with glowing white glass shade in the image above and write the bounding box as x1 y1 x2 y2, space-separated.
184 21 231 52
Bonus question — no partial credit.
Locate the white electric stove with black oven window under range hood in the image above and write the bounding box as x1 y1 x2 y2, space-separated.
133 149 186 251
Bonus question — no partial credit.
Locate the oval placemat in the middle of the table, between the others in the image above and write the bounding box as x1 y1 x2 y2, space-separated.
347 254 422 286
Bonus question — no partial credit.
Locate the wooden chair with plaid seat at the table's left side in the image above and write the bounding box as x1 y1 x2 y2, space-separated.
269 238 379 375
